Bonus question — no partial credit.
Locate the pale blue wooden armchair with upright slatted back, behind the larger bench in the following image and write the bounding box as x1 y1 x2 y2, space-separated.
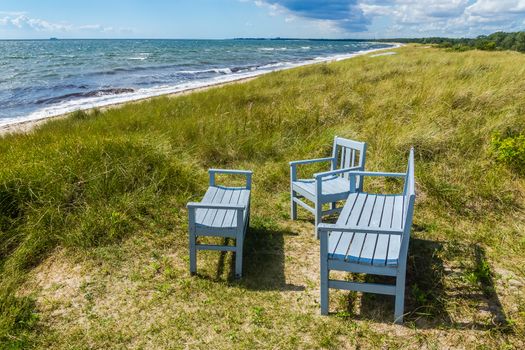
290 136 366 237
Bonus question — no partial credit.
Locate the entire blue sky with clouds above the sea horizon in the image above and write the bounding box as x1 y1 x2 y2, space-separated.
0 0 525 39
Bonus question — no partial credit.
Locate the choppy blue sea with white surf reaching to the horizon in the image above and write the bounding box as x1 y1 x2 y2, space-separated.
0 40 389 125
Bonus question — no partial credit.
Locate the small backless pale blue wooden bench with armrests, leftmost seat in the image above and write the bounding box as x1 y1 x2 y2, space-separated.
188 169 252 277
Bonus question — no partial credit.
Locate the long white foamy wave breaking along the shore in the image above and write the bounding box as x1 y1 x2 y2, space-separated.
0 44 402 127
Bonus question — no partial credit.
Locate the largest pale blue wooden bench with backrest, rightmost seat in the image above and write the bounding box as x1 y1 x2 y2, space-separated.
319 149 416 323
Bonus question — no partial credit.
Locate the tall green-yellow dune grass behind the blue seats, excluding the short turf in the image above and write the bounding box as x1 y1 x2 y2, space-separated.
0 46 525 345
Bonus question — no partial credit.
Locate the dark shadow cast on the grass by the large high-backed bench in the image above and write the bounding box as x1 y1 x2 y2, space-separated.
338 234 512 332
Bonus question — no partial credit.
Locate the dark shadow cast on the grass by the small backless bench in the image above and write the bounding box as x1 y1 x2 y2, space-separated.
211 217 305 291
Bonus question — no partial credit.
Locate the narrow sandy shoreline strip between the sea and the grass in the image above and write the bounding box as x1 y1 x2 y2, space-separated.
0 43 404 137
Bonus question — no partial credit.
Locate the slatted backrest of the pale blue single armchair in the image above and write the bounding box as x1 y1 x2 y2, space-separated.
332 136 366 191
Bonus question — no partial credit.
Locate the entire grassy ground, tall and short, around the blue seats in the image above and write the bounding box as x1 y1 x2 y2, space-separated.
0 46 525 349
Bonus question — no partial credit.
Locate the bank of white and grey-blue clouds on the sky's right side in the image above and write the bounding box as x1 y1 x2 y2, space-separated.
243 0 525 37
